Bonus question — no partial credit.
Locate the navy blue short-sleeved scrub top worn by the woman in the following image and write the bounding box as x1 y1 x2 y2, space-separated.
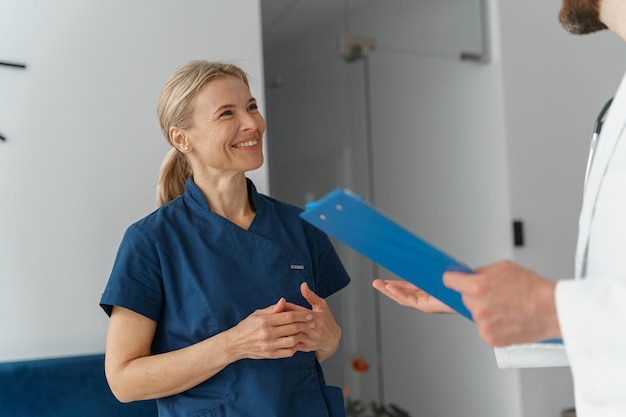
100 179 350 417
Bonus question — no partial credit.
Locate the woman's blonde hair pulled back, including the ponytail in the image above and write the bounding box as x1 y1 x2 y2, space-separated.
157 60 250 206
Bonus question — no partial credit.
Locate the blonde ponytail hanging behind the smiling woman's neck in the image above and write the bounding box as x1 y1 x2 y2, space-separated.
157 148 191 206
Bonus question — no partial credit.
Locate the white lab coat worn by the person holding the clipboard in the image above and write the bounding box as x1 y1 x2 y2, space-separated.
496 70 626 417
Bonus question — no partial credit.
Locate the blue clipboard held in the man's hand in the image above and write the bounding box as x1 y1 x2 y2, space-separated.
300 189 473 320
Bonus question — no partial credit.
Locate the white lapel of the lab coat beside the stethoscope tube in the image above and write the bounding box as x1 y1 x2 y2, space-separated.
576 76 626 278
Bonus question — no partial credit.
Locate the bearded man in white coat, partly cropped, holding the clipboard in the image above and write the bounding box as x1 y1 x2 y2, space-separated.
373 0 626 417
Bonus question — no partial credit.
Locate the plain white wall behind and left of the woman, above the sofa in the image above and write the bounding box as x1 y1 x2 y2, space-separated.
0 0 268 360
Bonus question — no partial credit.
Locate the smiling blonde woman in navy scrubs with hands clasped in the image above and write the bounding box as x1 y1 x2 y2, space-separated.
100 61 349 417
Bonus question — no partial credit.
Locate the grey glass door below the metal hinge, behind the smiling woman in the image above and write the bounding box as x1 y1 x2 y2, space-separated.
266 48 380 401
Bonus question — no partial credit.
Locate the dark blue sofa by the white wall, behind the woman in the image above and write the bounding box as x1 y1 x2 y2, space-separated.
0 354 158 417
